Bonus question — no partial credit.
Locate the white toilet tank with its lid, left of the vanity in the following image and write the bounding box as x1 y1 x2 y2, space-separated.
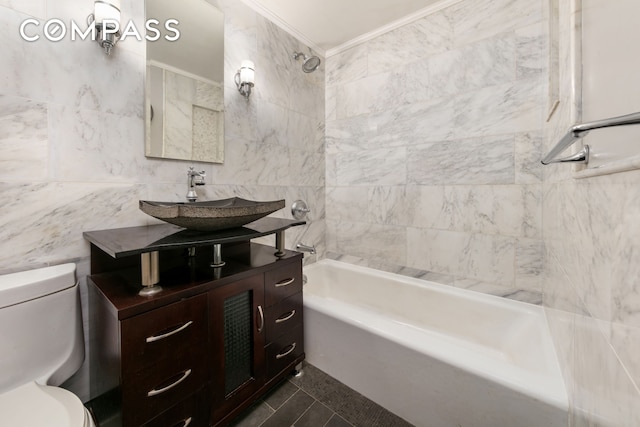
0 264 84 393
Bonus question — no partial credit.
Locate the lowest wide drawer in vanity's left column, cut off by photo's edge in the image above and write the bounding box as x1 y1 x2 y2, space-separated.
143 391 209 427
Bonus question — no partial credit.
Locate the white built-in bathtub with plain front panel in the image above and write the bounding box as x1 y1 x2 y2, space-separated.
304 260 568 427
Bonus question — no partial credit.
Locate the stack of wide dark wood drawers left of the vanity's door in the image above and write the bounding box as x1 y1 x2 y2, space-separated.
121 295 208 426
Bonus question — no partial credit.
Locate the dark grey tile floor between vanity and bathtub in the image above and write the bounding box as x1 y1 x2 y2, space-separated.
230 364 412 427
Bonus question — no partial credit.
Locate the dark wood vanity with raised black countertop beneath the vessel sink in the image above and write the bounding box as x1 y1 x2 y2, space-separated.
85 218 304 427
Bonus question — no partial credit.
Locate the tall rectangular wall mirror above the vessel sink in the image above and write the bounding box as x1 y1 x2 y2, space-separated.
145 0 224 163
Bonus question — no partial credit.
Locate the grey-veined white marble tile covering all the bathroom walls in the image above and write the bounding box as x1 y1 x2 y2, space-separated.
0 0 640 426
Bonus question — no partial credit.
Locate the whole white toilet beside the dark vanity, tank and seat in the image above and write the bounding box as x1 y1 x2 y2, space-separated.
0 264 95 427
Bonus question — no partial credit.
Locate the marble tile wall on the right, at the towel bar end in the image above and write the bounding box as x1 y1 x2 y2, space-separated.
543 0 640 427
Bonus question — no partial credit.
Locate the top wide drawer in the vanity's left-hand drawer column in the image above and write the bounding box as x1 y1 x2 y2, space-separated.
121 295 207 376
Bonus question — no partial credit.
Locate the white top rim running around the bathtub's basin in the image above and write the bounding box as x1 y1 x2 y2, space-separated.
303 259 569 410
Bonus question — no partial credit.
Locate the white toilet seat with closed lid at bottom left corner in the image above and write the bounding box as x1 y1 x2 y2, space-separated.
0 382 95 427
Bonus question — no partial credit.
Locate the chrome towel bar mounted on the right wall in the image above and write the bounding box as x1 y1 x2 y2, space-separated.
541 112 640 165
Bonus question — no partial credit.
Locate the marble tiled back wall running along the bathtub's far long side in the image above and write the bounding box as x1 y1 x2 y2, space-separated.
326 0 547 293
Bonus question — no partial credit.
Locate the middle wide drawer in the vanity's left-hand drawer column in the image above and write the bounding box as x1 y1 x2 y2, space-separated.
122 357 207 426
